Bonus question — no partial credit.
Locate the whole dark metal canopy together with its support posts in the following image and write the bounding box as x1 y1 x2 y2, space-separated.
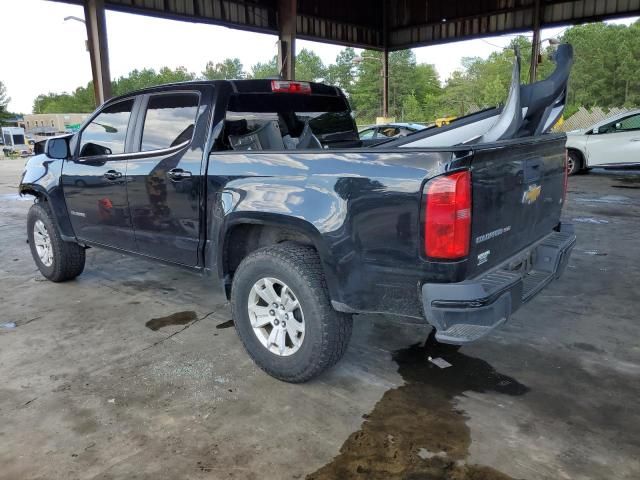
53 0 640 110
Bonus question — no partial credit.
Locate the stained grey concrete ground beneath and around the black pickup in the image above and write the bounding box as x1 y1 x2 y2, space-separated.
0 160 640 479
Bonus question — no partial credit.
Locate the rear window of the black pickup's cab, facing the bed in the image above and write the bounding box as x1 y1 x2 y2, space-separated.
216 81 360 151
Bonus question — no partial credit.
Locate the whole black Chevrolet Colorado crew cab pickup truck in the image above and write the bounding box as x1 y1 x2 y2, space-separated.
19 46 575 382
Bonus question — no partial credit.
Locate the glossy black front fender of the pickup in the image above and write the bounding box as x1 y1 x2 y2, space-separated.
18 154 76 242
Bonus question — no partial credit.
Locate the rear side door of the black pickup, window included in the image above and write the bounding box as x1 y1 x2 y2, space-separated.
127 87 211 266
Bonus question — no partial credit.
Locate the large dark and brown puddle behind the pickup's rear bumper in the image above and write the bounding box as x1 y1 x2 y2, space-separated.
307 336 529 480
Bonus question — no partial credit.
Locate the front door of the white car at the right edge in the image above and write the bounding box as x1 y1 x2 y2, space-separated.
587 113 640 167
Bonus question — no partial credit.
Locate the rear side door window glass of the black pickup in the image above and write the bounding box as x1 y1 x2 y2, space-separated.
140 93 199 151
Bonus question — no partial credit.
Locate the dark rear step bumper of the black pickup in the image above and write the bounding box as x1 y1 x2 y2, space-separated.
422 224 576 345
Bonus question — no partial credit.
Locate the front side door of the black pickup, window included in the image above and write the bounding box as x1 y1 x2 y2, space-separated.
62 99 135 251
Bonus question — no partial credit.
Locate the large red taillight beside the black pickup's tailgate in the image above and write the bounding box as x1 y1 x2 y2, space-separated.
424 170 471 260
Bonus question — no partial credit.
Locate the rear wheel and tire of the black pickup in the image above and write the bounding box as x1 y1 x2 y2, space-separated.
231 243 353 383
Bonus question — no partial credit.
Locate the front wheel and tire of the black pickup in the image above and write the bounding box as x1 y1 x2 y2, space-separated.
27 202 85 282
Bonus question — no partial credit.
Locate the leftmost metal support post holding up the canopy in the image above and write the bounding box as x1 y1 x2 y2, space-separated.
84 0 111 106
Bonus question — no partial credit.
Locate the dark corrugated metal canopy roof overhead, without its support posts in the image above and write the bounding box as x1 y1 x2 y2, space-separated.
56 0 640 51
